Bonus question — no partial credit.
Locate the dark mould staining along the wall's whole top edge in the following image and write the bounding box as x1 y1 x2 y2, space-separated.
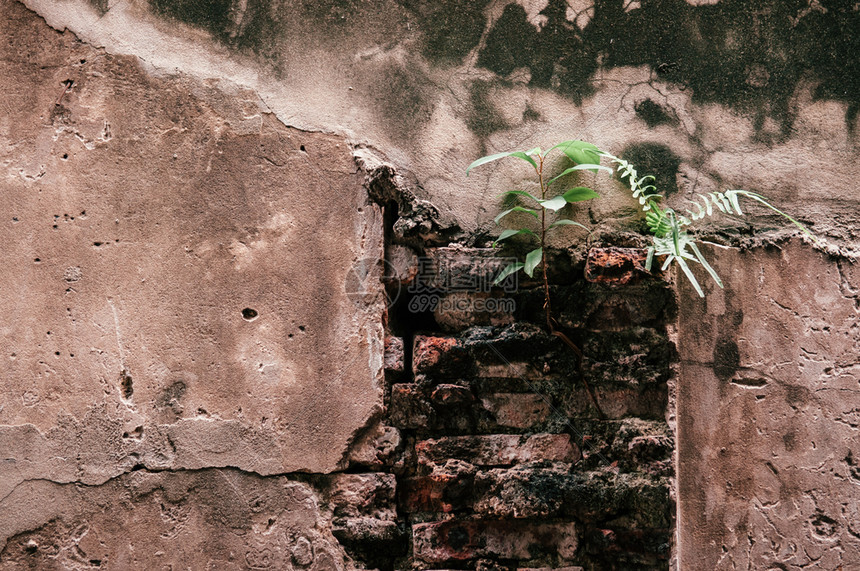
126 0 860 134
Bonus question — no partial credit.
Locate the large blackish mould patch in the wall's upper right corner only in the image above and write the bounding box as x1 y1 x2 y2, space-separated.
478 0 860 134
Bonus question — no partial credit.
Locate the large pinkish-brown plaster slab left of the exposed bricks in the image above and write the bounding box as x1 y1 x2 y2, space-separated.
0 1 385 565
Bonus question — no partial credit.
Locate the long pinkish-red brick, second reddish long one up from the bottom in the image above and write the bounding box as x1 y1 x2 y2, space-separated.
415 434 580 466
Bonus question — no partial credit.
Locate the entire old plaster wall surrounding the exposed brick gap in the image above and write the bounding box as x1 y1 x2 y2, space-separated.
0 0 860 569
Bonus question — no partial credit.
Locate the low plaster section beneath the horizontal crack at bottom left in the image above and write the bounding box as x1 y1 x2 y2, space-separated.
0 469 345 571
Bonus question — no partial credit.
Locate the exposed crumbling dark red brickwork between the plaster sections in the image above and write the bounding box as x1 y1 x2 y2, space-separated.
336 248 675 570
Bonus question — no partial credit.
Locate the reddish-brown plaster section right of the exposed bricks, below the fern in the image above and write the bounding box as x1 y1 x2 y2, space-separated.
678 241 860 571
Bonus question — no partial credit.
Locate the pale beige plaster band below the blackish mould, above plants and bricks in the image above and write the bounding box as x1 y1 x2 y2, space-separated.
18 0 860 249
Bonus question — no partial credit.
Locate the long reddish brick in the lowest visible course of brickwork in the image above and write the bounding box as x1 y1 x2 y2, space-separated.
412 519 578 563
